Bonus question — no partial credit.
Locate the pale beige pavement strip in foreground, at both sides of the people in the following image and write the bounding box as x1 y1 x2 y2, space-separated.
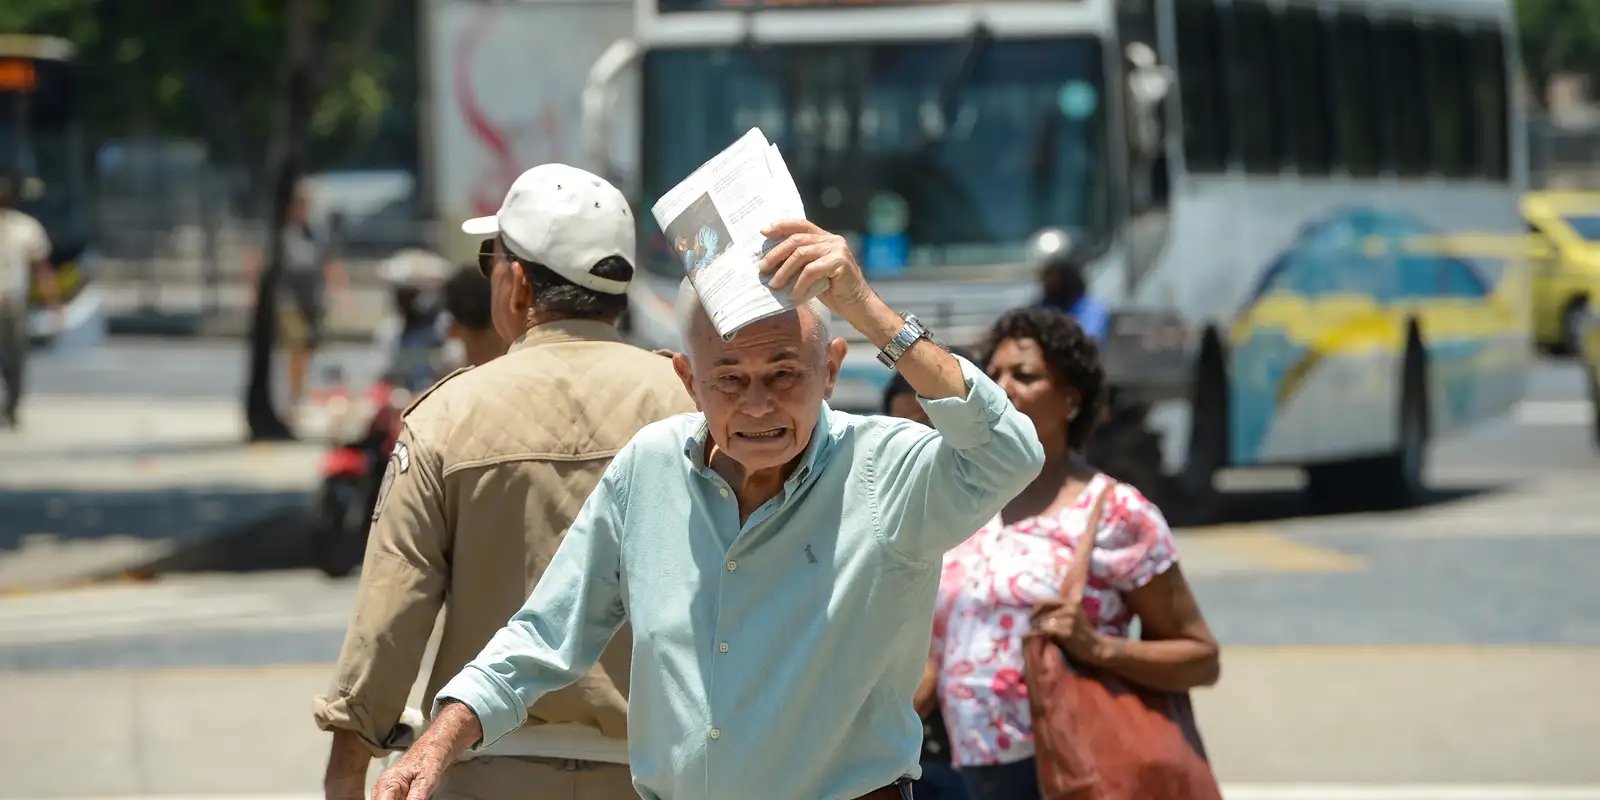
0 646 1600 800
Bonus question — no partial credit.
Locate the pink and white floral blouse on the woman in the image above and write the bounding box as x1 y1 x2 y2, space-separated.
933 474 1178 766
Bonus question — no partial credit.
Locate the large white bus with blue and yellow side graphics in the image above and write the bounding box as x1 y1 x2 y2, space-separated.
586 0 1528 506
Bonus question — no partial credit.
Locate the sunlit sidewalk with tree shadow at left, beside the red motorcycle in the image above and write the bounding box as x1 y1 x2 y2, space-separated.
0 395 325 592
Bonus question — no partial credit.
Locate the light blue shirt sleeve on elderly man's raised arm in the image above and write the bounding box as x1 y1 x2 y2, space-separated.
867 357 1045 565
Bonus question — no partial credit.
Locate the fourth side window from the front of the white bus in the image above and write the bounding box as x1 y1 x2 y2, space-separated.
1333 11 1389 176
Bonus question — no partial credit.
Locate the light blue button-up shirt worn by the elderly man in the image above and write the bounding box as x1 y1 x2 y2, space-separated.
434 360 1045 800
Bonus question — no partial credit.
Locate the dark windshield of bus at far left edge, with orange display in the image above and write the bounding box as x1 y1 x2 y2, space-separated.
0 56 88 258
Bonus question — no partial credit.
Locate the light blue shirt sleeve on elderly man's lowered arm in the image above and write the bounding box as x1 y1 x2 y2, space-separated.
432 448 630 750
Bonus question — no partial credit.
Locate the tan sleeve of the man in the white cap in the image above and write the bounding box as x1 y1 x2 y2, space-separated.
314 427 453 755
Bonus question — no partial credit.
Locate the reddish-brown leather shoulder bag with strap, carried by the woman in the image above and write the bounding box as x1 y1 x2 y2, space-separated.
1022 483 1222 800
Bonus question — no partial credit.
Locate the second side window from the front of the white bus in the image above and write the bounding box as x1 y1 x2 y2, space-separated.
1232 2 1288 173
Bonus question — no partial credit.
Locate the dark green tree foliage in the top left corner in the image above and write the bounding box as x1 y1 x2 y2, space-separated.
0 0 416 178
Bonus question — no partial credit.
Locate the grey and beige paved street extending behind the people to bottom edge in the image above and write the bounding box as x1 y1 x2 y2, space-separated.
0 344 1600 800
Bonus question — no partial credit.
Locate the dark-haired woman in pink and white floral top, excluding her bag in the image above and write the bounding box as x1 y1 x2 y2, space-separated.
933 309 1219 800
